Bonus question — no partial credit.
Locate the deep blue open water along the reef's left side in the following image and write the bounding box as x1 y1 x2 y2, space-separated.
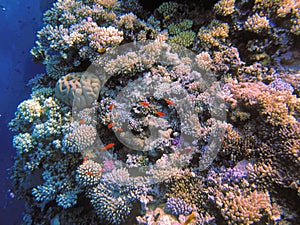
0 0 45 225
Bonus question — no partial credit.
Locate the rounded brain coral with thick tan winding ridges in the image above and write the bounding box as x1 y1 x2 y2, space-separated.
55 72 100 108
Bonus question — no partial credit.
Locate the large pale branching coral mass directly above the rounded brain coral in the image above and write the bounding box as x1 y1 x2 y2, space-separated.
31 0 161 74
